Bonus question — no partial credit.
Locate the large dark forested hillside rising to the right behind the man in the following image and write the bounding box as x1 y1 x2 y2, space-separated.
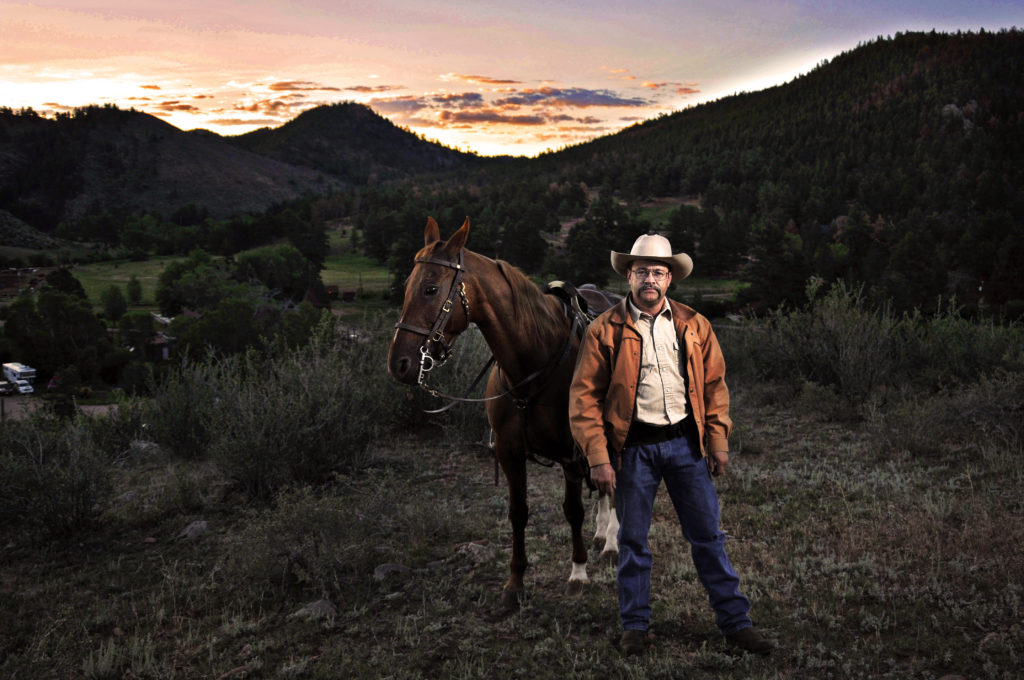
539 31 1024 311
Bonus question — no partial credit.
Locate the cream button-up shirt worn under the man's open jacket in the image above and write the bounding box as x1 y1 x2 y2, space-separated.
629 300 687 425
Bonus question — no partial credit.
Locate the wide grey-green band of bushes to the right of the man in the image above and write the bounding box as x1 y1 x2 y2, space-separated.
722 282 1024 403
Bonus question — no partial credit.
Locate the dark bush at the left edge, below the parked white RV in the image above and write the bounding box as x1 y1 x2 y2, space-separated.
0 415 112 537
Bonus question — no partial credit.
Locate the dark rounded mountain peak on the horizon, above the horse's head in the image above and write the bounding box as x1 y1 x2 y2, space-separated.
229 102 481 184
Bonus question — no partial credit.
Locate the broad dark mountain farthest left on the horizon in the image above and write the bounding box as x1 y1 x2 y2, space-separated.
0 107 343 229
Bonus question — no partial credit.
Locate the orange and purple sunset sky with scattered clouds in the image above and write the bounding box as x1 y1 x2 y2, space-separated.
6 0 1024 156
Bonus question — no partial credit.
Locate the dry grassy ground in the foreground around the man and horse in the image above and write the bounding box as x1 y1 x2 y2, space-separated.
0 374 1024 679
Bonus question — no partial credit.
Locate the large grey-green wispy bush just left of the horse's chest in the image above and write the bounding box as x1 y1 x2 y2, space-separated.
201 317 399 498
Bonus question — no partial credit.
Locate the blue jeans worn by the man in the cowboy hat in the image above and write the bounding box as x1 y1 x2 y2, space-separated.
615 434 752 635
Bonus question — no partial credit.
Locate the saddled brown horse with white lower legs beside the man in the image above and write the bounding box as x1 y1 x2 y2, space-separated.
388 218 618 607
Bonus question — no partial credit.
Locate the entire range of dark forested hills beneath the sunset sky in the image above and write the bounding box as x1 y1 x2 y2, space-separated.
0 29 1024 315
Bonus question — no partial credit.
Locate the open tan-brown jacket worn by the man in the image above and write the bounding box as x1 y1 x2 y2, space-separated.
569 298 732 466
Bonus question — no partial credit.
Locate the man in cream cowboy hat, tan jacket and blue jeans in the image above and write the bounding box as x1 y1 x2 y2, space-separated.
569 235 771 654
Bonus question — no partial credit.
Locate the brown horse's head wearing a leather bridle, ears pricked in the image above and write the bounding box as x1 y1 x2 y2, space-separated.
387 217 469 385
